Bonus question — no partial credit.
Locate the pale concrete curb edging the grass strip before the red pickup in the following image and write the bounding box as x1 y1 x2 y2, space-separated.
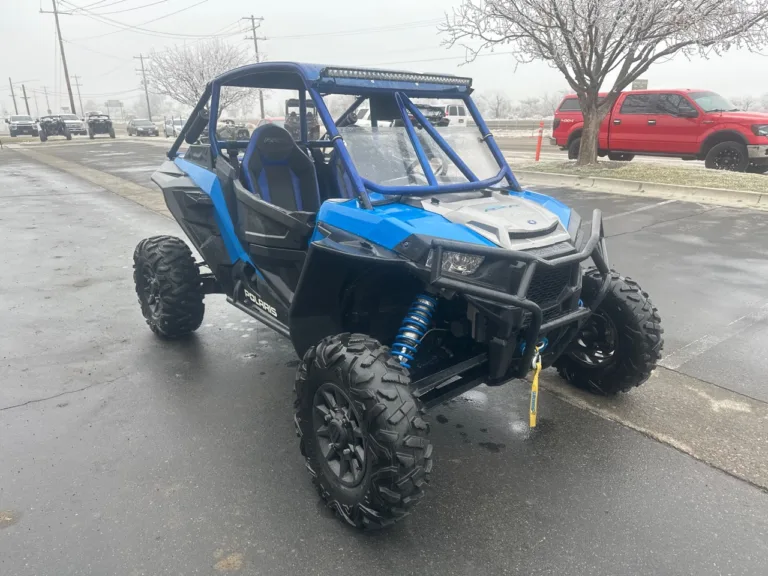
515 170 768 210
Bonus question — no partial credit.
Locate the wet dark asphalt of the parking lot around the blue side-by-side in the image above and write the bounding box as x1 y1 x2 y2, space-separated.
0 141 768 576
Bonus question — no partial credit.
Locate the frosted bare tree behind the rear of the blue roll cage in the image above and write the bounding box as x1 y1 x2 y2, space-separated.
148 38 254 113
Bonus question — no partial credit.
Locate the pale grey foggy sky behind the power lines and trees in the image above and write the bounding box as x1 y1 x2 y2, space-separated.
0 0 768 114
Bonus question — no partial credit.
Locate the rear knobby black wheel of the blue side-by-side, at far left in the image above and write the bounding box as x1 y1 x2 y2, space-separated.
133 236 205 338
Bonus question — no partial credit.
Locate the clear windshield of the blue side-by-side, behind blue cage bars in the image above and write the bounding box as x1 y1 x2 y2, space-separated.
339 125 499 186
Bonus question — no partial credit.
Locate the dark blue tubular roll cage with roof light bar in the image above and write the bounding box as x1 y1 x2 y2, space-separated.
168 62 521 208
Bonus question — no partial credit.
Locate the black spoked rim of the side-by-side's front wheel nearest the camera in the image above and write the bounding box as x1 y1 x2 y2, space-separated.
312 382 365 487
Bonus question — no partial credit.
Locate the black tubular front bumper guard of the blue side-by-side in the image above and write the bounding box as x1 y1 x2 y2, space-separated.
429 210 610 380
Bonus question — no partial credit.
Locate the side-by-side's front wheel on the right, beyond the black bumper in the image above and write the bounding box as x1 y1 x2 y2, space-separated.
555 268 664 396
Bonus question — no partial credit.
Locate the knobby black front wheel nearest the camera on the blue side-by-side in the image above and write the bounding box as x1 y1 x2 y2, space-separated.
295 333 432 529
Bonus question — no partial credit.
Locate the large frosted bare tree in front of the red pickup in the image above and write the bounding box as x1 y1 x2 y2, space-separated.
439 0 768 164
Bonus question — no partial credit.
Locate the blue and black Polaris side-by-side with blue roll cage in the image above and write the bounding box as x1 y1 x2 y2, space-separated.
134 62 663 528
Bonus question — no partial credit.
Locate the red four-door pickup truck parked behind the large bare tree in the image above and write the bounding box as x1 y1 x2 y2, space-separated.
550 90 768 174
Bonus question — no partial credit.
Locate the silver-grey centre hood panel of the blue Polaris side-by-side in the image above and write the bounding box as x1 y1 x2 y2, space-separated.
407 192 570 250
